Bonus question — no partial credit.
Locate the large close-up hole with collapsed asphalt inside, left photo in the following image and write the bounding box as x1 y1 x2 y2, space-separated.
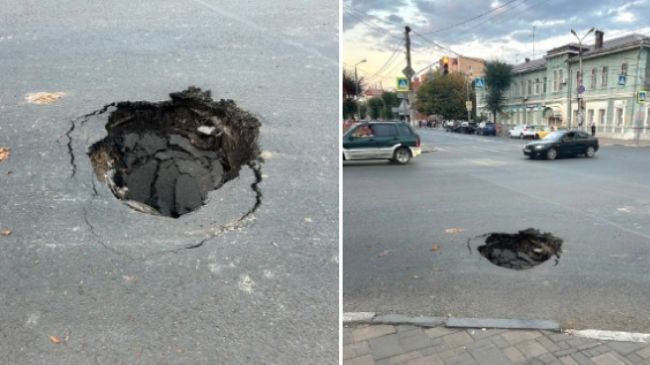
88 87 260 218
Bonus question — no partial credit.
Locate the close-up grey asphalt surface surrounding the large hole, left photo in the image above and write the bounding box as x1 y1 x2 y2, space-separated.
0 0 339 364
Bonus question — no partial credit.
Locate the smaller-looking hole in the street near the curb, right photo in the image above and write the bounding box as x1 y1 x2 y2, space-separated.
478 228 562 270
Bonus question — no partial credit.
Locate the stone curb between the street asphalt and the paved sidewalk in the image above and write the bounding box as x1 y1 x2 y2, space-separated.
343 312 650 343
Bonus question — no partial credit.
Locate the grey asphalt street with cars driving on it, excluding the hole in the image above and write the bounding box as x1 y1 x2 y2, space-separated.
343 129 650 332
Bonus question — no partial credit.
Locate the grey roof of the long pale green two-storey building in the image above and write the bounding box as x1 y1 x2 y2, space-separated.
512 33 650 74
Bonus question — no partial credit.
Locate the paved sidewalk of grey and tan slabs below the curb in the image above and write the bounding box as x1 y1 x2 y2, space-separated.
343 325 650 365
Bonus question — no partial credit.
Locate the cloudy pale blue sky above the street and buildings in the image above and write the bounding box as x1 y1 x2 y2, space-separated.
342 0 650 90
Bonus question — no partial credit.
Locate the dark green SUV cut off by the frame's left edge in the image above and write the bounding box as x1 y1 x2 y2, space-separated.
343 122 422 164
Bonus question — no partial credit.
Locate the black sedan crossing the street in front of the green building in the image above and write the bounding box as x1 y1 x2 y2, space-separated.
523 131 599 160
